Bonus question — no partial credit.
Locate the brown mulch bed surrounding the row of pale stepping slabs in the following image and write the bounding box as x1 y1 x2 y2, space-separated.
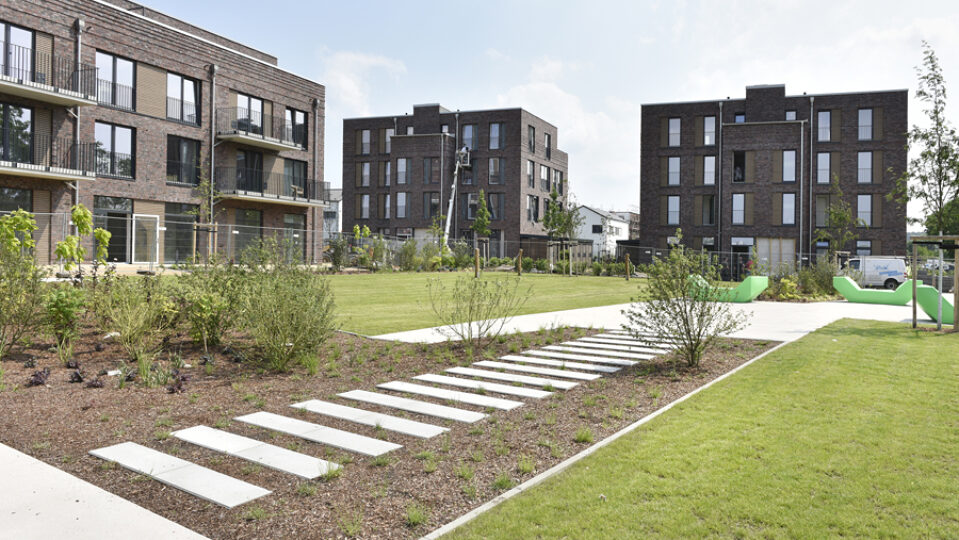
0 322 776 539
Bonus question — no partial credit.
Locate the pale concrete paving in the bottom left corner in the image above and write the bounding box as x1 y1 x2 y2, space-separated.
0 444 206 540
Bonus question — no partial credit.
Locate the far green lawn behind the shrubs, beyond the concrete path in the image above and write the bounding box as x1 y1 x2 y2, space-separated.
330 272 642 335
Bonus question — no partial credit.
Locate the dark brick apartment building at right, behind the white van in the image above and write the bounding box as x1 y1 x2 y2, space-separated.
641 85 908 266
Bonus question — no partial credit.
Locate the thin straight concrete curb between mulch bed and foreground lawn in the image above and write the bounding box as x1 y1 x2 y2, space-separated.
421 341 792 540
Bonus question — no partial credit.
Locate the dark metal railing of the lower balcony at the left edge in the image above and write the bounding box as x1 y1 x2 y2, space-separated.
0 127 96 173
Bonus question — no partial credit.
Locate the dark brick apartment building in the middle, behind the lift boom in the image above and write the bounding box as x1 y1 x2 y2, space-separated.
343 104 569 256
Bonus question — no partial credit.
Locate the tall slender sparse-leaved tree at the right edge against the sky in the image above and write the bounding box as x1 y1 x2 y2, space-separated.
889 41 959 232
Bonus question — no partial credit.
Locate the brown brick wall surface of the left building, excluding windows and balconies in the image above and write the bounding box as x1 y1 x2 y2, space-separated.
0 0 325 260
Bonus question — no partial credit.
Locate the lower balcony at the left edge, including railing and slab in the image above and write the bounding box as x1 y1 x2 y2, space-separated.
0 129 96 182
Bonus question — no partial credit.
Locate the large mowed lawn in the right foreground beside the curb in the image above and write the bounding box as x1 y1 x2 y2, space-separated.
445 320 959 539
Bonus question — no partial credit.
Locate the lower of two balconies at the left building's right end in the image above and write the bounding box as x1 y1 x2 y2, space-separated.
216 167 329 206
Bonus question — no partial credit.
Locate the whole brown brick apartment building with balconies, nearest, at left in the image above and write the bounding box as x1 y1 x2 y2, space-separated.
0 0 325 263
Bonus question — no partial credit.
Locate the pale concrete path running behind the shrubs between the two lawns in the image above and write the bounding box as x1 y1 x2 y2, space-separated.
375 301 931 343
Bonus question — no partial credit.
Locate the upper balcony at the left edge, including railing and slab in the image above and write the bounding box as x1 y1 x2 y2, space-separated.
0 44 97 107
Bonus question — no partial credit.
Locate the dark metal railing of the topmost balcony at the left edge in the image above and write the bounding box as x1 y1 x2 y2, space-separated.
0 43 97 101
